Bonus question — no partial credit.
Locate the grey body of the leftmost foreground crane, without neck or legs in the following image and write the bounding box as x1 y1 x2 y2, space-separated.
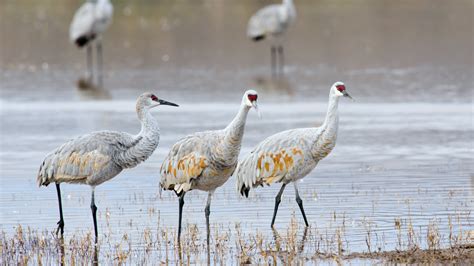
38 131 159 186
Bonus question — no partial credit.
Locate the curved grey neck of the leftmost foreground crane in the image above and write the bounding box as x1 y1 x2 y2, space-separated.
115 107 160 168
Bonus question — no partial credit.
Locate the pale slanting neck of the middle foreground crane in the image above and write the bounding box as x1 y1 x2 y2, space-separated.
217 102 250 166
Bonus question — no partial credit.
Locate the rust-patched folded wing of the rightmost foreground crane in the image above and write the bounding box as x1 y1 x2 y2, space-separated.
235 128 317 196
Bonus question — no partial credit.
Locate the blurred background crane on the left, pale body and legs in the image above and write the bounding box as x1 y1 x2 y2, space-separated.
69 0 113 85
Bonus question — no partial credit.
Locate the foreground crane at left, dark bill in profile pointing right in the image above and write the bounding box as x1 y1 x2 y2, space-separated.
37 92 178 243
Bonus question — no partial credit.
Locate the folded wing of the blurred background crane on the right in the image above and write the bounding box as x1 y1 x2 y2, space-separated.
247 5 284 40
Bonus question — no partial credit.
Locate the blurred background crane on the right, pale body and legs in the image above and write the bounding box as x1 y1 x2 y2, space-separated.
247 0 296 74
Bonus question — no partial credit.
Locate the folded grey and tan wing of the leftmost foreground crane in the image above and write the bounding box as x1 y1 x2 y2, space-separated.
37 131 139 186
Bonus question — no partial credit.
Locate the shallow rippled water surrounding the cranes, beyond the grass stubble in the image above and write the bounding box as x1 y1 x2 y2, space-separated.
0 1 474 262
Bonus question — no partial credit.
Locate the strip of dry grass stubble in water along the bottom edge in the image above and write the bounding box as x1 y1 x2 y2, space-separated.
0 213 474 265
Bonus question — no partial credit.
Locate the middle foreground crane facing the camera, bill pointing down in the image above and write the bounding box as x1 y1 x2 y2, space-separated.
160 90 258 244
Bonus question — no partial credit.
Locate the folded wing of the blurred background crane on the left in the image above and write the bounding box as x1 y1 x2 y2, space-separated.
69 2 95 47
